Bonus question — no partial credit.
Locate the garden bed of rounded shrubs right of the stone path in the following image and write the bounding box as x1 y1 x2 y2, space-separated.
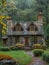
32 44 49 65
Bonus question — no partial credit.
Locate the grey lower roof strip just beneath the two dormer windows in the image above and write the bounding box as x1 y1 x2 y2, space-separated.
7 31 44 36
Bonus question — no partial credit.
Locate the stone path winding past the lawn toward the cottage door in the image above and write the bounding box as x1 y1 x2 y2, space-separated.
26 51 47 65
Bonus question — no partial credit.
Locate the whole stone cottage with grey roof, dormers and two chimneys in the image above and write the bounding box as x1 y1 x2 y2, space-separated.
2 12 45 46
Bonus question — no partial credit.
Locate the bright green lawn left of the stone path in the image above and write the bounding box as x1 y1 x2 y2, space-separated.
0 51 32 65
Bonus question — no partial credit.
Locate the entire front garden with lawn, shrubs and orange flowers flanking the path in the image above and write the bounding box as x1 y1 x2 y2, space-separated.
0 44 49 65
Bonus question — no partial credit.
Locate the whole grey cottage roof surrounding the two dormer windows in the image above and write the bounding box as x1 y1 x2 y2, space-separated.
8 22 44 35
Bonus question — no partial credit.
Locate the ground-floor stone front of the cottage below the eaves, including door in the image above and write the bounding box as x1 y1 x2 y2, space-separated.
8 36 44 46
